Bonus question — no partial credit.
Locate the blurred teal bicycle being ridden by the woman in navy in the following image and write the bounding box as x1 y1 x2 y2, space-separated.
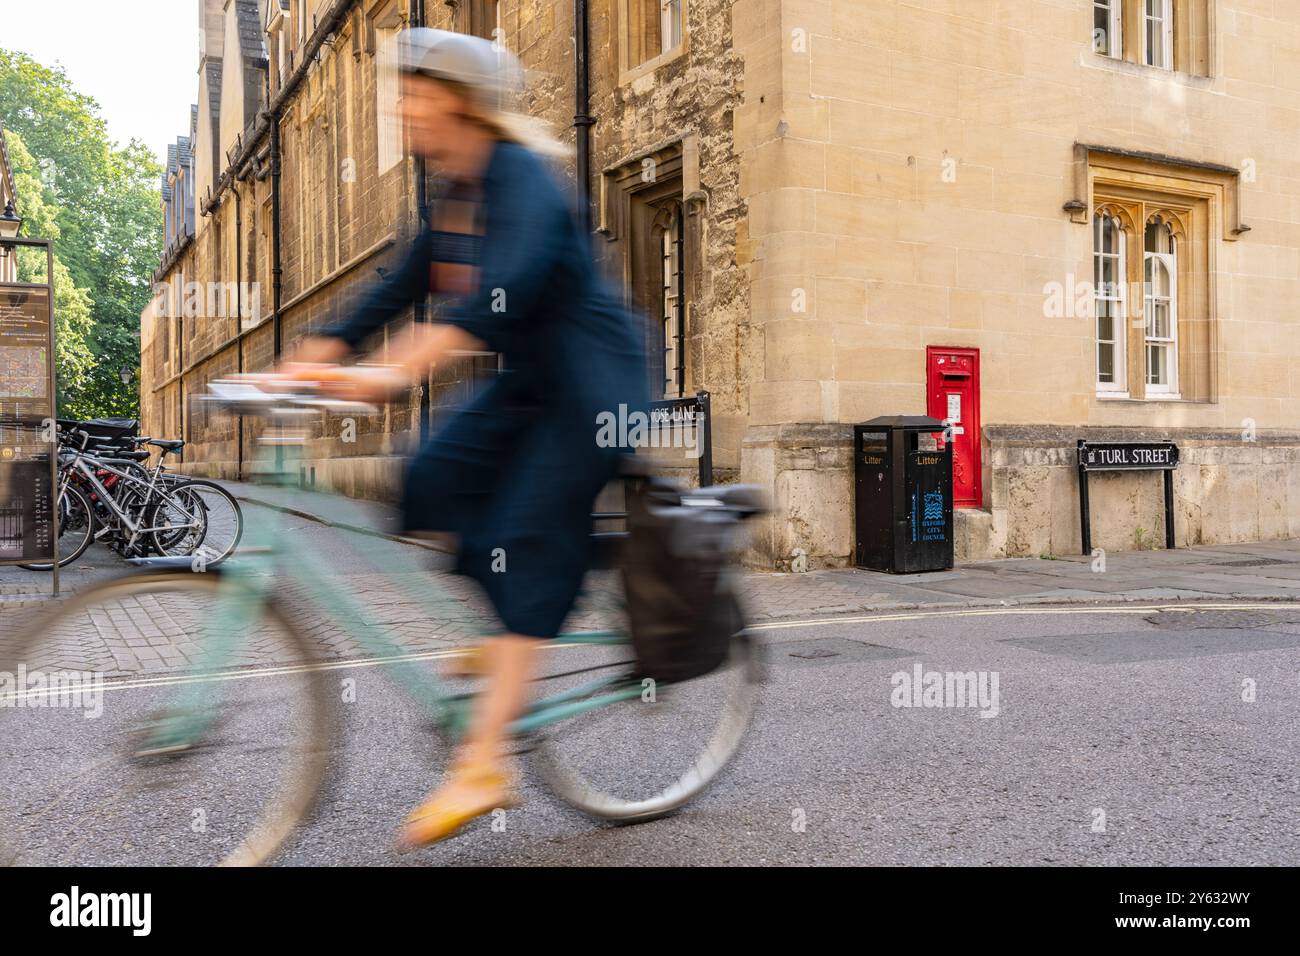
0 382 762 865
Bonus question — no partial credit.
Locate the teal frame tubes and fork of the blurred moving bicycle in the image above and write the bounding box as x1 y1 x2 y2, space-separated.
144 429 642 752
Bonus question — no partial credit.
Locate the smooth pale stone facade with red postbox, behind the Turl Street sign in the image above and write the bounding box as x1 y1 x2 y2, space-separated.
732 0 1300 564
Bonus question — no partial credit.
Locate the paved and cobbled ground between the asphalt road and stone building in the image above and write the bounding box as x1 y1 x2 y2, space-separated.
0 484 1300 676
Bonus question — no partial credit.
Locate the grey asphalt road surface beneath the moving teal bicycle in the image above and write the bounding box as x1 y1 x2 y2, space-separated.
0 595 1300 866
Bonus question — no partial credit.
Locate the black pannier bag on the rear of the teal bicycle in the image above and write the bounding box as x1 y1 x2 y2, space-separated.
623 477 763 683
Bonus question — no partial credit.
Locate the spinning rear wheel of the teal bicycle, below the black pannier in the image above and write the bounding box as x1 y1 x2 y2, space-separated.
534 574 763 823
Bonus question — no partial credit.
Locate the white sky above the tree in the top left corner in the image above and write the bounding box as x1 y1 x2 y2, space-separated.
0 0 199 163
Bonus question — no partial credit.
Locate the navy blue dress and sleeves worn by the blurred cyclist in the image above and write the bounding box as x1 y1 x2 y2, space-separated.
324 142 647 637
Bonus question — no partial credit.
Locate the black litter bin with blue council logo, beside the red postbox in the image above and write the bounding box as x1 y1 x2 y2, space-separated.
853 415 953 574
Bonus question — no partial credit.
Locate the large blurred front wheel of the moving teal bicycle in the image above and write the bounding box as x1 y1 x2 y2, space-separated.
0 572 333 866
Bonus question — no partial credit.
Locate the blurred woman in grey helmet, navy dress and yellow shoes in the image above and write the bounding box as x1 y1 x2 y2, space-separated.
287 29 646 847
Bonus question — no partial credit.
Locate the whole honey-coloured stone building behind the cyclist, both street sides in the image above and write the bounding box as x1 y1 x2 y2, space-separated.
144 0 1300 567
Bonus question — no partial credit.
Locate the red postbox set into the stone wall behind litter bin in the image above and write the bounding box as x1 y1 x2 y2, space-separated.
926 345 984 507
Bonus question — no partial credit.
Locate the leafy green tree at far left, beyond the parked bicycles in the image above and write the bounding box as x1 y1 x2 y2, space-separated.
0 49 163 415
